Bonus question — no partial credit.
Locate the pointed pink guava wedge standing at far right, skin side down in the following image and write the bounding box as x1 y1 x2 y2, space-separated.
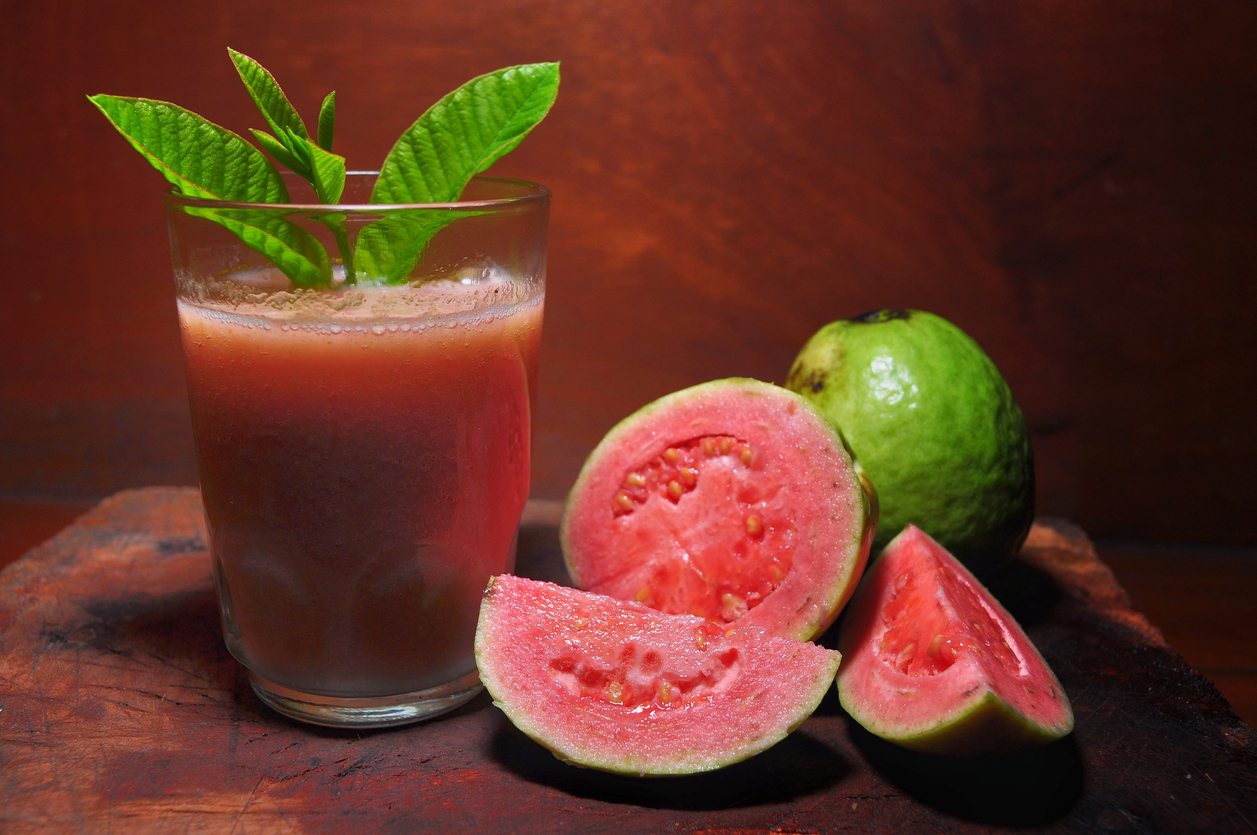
837 524 1073 757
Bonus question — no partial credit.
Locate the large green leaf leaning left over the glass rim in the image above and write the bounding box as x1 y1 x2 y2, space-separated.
88 94 332 287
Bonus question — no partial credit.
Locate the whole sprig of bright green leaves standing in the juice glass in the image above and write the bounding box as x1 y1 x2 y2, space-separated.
88 49 559 287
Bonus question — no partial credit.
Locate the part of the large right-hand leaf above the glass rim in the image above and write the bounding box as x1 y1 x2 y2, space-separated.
370 63 558 204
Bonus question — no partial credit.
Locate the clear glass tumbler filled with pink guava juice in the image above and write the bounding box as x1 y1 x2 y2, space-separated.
166 174 549 727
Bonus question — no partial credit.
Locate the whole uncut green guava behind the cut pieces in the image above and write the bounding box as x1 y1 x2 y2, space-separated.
786 311 1035 567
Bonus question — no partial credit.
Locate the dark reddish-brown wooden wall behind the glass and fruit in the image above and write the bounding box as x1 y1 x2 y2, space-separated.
0 0 1257 545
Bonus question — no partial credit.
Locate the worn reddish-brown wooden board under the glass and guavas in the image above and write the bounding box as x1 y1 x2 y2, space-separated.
0 488 1257 835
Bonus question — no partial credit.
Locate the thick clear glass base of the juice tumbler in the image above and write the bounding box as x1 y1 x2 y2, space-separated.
249 670 484 728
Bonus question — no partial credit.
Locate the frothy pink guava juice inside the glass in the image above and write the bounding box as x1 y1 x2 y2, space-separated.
178 270 544 698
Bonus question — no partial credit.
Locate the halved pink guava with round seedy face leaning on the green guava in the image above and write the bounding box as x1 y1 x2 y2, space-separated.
559 379 877 640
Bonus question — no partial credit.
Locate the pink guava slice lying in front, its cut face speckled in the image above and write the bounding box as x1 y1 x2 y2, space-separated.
475 575 841 775
